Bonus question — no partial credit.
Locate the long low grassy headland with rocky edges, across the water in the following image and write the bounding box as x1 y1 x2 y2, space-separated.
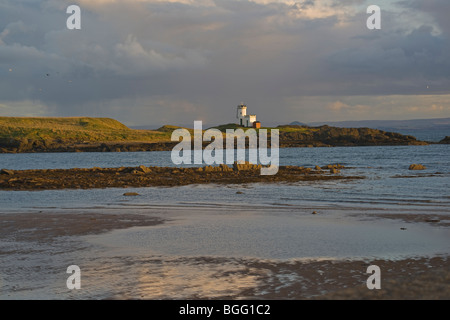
0 117 426 153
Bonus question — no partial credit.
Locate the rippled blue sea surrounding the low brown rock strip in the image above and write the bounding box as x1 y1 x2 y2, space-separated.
0 145 450 213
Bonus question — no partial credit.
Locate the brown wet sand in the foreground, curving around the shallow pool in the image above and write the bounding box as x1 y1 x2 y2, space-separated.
0 212 450 300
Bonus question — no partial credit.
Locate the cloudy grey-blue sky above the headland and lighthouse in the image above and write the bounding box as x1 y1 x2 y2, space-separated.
0 0 450 127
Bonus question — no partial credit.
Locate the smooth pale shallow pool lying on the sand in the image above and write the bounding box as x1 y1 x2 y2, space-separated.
87 207 450 260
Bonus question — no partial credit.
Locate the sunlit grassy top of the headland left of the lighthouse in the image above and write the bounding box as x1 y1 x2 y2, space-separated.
0 117 170 142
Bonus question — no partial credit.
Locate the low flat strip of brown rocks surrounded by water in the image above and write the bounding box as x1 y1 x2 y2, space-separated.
0 164 363 190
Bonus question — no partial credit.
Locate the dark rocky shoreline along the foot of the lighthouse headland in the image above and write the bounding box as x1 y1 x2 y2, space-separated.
0 125 430 153
